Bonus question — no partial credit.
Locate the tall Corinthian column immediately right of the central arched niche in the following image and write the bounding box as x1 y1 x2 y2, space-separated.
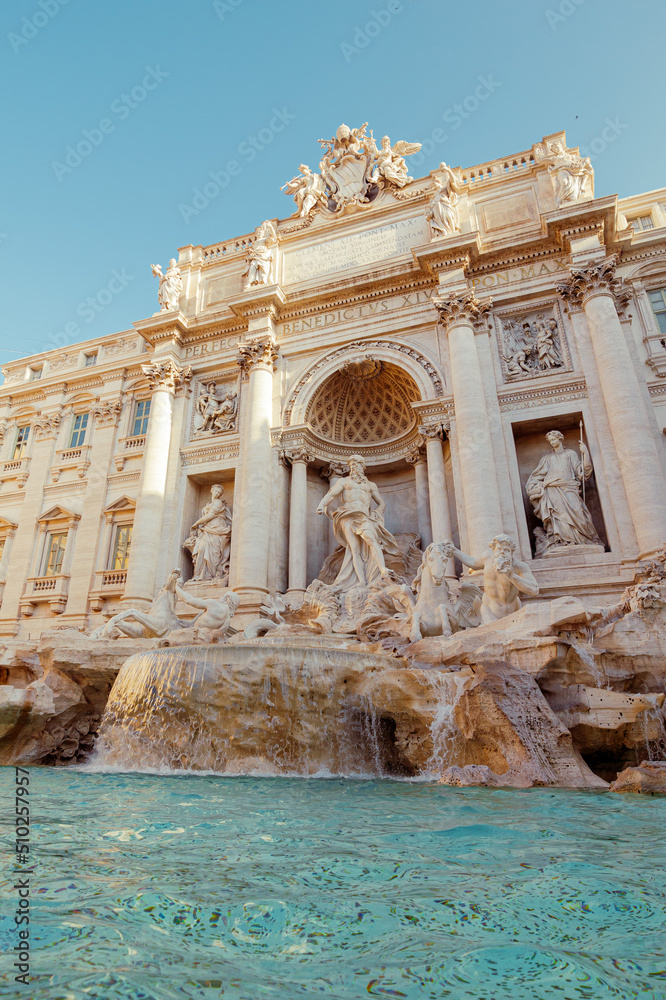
428 291 502 554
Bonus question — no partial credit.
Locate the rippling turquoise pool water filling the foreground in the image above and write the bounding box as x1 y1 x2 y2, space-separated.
0 768 666 1000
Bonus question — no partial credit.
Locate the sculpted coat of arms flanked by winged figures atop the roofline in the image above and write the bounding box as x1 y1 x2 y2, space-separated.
282 122 421 217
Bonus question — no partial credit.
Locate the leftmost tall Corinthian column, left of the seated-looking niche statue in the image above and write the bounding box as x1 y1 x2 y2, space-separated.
122 359 192 607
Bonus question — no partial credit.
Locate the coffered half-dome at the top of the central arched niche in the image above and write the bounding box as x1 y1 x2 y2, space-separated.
306 355 421 446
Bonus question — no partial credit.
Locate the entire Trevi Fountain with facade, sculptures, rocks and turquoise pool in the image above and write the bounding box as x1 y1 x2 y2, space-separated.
0 125 666 1000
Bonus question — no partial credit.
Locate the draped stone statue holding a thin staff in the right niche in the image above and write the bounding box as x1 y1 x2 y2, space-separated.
526 431 600 551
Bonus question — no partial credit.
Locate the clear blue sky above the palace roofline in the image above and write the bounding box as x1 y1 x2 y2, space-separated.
0 0 666 364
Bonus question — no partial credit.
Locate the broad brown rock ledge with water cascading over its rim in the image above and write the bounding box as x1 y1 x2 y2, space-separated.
93 637 460 777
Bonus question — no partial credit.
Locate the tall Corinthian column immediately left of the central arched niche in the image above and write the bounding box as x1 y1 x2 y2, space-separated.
234 333 278 612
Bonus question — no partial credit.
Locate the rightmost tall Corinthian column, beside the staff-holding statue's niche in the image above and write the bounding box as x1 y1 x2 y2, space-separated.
558 256 666 558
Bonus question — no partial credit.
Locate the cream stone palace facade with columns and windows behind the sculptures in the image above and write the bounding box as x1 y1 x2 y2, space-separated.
0 127 666 636
